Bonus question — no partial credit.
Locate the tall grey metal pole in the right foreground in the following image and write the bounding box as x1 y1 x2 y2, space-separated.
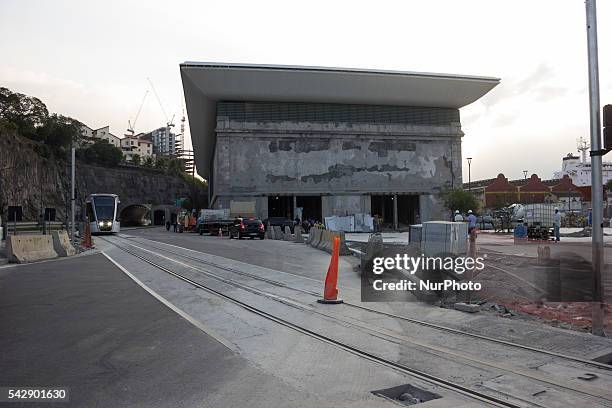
584 0 605 336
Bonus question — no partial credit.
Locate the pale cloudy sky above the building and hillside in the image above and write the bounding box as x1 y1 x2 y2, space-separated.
0 0 612 180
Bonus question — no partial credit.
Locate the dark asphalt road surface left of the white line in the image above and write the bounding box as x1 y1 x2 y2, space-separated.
0 254 332 408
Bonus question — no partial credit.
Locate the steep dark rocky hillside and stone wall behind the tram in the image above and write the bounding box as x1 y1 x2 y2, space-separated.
0 127 198 221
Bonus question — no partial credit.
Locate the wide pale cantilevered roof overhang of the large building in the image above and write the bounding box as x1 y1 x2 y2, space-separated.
180 62 500 178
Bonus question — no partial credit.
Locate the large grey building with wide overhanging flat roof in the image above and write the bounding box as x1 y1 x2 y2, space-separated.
180 62 499 228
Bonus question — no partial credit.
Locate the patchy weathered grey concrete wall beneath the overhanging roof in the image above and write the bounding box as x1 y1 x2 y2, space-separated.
213 119 463 219
